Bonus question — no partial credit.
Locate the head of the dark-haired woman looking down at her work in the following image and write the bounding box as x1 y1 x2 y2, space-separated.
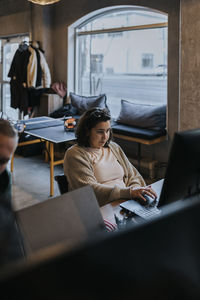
76 107 112 148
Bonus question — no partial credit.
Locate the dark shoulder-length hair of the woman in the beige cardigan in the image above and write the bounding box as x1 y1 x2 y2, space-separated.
75 107 112 147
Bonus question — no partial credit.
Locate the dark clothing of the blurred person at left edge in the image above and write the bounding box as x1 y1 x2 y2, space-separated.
0 170 24 267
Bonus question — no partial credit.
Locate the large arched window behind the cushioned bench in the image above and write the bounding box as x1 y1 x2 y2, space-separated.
72 6 168 117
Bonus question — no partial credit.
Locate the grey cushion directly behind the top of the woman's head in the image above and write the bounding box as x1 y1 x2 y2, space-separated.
70 93 107 115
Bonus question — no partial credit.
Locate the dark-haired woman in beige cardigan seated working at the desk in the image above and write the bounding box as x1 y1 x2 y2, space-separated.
64 108 156 206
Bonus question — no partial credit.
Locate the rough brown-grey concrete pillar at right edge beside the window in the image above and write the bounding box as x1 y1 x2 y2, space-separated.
179 0 200 130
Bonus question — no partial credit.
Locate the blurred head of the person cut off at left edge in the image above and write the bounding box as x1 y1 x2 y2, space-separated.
0 119 18 174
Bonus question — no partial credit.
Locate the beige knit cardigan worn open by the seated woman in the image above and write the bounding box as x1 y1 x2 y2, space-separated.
64 142 146 206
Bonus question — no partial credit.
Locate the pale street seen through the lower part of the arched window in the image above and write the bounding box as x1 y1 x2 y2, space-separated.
83 75 167 117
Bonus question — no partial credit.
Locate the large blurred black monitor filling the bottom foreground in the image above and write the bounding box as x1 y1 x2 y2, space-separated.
0 197 200 300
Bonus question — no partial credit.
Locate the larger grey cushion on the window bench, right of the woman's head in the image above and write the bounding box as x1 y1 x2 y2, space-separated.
116 100 166 130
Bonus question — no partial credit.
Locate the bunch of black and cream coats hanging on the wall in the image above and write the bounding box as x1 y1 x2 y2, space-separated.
8 41 51 115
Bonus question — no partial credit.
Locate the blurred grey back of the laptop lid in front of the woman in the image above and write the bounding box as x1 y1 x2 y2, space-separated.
16 186 105 254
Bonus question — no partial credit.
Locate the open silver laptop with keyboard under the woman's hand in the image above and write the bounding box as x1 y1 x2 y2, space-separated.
120 179 164 219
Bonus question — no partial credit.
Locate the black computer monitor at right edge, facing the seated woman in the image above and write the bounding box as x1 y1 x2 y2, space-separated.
159 129 200 206
